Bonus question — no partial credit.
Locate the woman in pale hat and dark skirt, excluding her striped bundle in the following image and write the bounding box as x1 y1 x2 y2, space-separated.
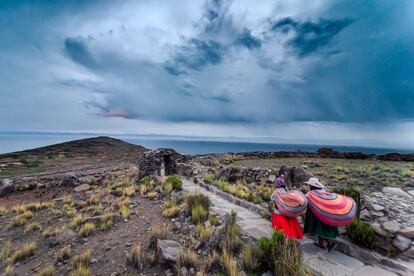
303 177 339 251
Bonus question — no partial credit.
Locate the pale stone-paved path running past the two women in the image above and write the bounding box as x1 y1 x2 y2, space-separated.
183 180 414 276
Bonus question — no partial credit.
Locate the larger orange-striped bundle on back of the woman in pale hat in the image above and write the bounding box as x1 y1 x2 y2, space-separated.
306 190 356 227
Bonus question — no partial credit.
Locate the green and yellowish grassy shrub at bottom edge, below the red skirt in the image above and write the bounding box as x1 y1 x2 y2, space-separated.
259 231 308 276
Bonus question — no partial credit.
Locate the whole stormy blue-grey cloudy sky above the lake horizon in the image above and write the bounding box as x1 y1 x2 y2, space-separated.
0 0 414 148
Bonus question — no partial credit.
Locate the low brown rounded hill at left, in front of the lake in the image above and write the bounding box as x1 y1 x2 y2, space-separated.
0 137 147 178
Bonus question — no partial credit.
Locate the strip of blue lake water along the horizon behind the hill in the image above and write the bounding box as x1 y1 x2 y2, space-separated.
0 133 411 154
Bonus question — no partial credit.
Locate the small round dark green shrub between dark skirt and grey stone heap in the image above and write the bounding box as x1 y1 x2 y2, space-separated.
346 219 375 248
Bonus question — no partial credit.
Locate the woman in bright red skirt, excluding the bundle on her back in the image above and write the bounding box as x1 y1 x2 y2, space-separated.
271 174 303 240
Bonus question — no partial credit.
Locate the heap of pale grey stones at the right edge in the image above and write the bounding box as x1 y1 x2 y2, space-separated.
360 187 414 259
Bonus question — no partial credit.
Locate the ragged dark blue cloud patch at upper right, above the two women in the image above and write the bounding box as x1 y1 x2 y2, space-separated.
271 17 353 57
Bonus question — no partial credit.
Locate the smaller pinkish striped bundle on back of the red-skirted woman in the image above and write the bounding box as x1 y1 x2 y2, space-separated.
274 188 308 217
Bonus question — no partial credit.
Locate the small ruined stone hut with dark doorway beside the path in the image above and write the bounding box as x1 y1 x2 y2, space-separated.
138 148 185 178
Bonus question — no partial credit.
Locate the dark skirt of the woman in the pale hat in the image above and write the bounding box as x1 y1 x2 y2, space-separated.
303 208 339 239
